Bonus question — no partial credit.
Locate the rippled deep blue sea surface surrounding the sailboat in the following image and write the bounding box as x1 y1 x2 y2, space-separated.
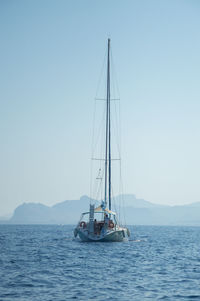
0 225 200 301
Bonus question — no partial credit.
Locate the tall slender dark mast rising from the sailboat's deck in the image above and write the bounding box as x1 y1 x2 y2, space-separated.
105 39 111 210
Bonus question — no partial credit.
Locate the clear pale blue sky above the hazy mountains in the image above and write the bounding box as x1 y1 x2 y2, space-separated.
0 0 200 216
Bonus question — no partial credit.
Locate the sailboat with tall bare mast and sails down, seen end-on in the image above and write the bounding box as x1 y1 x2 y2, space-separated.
74 39 130 242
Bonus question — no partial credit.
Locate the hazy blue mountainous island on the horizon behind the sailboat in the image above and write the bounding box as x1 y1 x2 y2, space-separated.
0 195 200 226
